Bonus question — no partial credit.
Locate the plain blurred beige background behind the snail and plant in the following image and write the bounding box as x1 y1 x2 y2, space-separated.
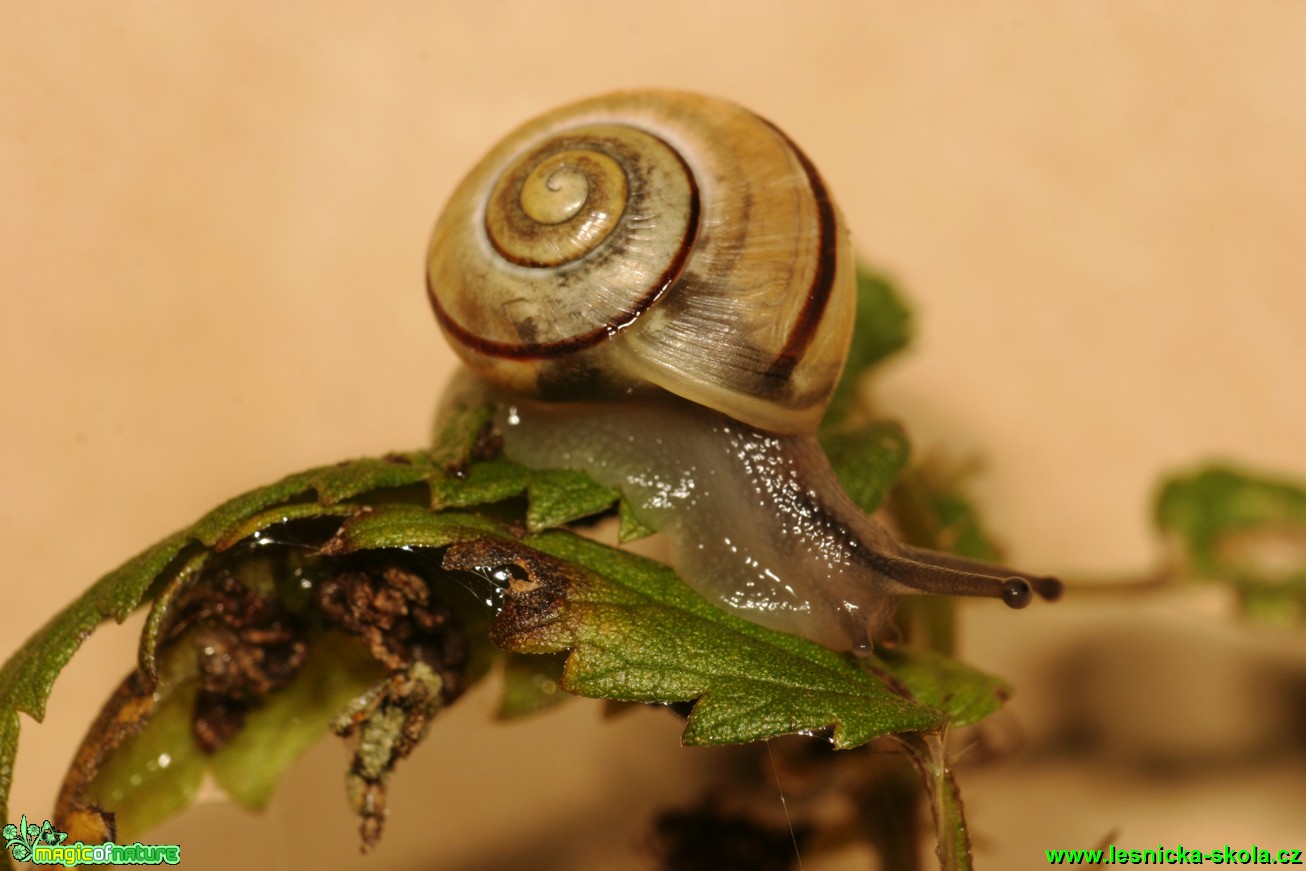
0 0 1306 868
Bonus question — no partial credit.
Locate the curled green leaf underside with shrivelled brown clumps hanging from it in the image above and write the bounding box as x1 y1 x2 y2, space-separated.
56 547 480 849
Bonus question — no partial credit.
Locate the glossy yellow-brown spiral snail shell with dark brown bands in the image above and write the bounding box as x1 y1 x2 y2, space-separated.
427 91 855 434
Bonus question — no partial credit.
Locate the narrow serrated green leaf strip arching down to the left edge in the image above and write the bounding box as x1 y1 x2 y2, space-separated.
0 413 653 846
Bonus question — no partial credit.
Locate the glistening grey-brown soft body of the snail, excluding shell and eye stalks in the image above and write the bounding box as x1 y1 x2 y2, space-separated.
485 389 910 650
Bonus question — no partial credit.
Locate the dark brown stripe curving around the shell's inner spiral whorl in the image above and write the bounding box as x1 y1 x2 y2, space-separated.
426 146 700 360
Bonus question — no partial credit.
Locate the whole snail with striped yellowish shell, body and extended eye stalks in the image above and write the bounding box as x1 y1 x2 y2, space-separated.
427 90 1060 652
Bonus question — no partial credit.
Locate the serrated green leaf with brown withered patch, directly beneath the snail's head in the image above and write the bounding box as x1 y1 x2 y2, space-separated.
444 533 942 747
